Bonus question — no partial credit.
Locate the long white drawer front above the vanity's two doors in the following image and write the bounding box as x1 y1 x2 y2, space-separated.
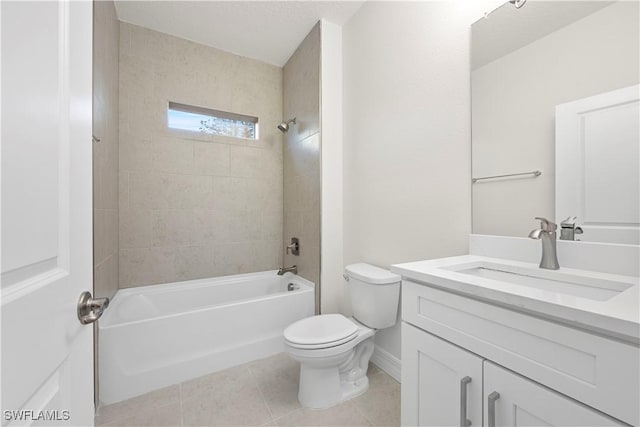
402 280 640 425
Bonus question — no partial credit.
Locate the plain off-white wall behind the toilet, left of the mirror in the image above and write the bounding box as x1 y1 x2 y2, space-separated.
342 1 497 357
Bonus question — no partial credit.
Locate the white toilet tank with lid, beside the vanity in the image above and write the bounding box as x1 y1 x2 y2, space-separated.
344 263 400 329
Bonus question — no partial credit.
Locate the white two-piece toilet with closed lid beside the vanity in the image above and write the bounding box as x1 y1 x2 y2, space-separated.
284 263 400 409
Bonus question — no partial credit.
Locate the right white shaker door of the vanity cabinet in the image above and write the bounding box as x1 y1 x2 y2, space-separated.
483 361 626 427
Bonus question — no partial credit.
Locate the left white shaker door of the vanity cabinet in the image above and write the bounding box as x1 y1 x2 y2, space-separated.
402 322 483 426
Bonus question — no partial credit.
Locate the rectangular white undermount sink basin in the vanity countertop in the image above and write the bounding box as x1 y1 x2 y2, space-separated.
440 261 634 301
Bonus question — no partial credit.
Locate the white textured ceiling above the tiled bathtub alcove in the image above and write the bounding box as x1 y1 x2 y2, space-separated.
116 0 363 66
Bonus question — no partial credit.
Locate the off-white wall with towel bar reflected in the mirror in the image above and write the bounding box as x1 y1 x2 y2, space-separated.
472 2 640 236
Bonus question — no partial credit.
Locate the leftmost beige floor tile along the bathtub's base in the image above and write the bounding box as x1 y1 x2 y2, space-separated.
95 385 180 426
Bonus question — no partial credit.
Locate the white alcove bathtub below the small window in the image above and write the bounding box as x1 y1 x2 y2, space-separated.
98 271 314 404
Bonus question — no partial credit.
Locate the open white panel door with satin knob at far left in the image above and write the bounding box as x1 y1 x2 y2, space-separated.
0 0 94 425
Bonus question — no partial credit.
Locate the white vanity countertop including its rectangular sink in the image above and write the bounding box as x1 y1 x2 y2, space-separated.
391 255 640 345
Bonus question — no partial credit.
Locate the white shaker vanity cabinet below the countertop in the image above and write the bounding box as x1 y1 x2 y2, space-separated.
402 280 640 427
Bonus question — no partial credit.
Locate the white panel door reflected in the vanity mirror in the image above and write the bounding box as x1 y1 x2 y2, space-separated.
556 85 640 245
